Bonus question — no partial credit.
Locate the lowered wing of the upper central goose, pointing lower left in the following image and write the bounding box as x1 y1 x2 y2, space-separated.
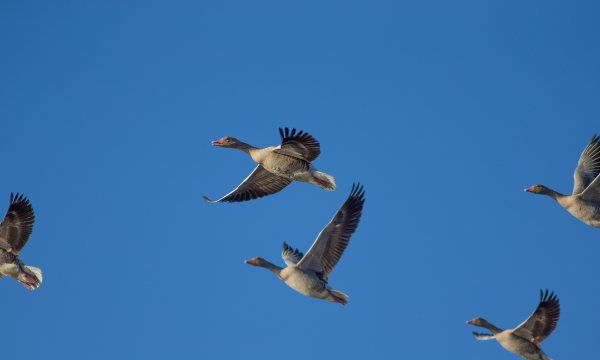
202 165 292 203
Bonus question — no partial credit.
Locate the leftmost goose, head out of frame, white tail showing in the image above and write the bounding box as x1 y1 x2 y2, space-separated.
0 193 42 290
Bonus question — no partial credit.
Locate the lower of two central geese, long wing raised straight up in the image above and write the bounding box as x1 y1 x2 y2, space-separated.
245 184 365 305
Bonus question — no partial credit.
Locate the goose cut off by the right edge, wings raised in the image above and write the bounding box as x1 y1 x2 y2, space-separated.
525 135 600 228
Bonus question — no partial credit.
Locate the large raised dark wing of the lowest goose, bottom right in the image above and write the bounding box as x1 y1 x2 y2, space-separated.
513 290 560 345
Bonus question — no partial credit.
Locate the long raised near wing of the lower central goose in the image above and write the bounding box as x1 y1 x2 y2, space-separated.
298 184 365 279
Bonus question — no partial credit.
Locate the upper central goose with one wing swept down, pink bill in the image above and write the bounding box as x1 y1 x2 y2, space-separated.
203 128 335 203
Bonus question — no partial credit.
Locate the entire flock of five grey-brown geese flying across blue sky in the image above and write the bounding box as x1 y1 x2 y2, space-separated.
0 128 600 360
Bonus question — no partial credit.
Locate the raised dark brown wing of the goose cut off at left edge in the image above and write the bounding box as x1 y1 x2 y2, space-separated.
0 193 35 255
